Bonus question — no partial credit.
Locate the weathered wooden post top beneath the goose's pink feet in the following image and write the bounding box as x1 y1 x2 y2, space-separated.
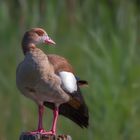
19 133 72 140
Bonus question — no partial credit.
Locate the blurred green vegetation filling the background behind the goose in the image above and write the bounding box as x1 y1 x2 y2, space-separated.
0 0 140 140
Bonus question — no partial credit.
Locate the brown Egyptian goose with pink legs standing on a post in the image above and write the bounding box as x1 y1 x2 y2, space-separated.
16 28 89 135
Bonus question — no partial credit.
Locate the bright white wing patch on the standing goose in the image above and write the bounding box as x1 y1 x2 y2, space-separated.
59 71 77 93
